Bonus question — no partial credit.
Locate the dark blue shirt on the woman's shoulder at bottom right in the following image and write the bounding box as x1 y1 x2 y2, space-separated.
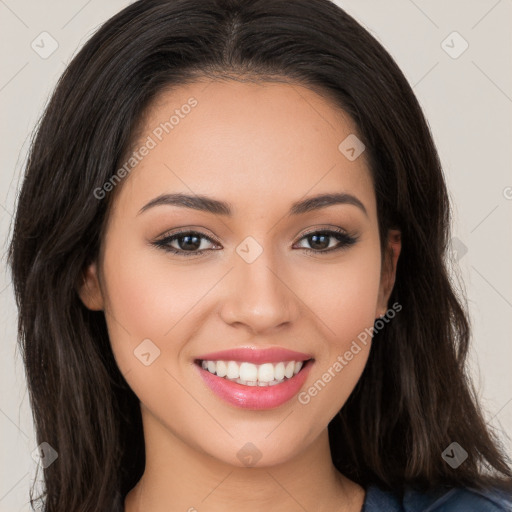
361 485 512 512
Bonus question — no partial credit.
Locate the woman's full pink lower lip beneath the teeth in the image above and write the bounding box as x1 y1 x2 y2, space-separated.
195 359 313 410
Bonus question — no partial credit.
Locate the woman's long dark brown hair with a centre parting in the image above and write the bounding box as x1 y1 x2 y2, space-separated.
9 0 512 512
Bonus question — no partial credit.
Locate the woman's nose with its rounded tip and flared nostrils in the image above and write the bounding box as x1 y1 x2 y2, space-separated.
220 244 300 335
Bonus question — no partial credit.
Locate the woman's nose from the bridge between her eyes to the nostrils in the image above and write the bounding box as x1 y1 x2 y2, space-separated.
221 237 297 331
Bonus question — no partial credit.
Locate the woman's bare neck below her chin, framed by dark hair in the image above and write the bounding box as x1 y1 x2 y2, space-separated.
125 407 364 512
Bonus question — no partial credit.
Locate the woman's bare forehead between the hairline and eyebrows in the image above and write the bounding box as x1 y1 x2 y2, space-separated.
114 80 373 219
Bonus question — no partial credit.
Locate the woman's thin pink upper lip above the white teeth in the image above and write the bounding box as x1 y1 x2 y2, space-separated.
196 347 312 364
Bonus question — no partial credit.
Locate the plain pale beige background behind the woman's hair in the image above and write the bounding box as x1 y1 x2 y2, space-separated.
0 0 512 512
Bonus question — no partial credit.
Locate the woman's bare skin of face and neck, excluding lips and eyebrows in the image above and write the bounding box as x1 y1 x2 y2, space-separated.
80 80 400 512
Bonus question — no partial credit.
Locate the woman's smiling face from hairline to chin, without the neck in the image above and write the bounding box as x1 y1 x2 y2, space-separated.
81 81 397 466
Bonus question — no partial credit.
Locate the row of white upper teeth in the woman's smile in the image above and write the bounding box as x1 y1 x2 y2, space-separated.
201 361 304 387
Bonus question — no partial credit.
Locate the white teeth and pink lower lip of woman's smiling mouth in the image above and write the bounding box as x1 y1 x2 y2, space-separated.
194 351 315 410
